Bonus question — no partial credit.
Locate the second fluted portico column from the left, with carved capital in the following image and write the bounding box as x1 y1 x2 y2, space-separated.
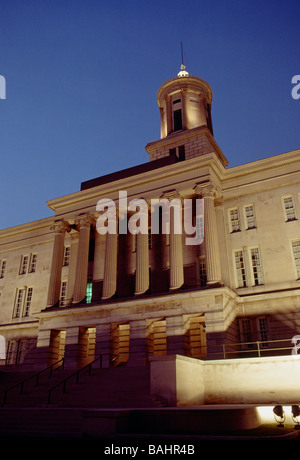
73 214 92 303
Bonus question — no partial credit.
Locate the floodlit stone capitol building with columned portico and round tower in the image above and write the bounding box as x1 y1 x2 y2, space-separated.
0 63 300 368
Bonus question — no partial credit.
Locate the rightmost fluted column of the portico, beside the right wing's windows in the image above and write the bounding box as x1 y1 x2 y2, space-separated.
194 183 221 284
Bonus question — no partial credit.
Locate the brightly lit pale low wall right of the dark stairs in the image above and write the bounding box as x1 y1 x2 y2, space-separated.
150 355 300 406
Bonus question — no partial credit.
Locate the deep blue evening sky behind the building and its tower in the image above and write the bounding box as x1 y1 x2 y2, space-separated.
0 0 300 229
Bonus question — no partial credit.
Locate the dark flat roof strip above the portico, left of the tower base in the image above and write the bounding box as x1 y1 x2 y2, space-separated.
80 155 178 190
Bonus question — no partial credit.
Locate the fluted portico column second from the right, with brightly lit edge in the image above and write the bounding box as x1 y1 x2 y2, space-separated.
163 191 184 289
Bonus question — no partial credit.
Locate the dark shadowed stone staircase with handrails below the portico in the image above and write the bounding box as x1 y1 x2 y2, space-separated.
0 367 157 407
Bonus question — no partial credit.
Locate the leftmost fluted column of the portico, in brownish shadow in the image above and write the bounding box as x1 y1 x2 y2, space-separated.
47 220 70 306
